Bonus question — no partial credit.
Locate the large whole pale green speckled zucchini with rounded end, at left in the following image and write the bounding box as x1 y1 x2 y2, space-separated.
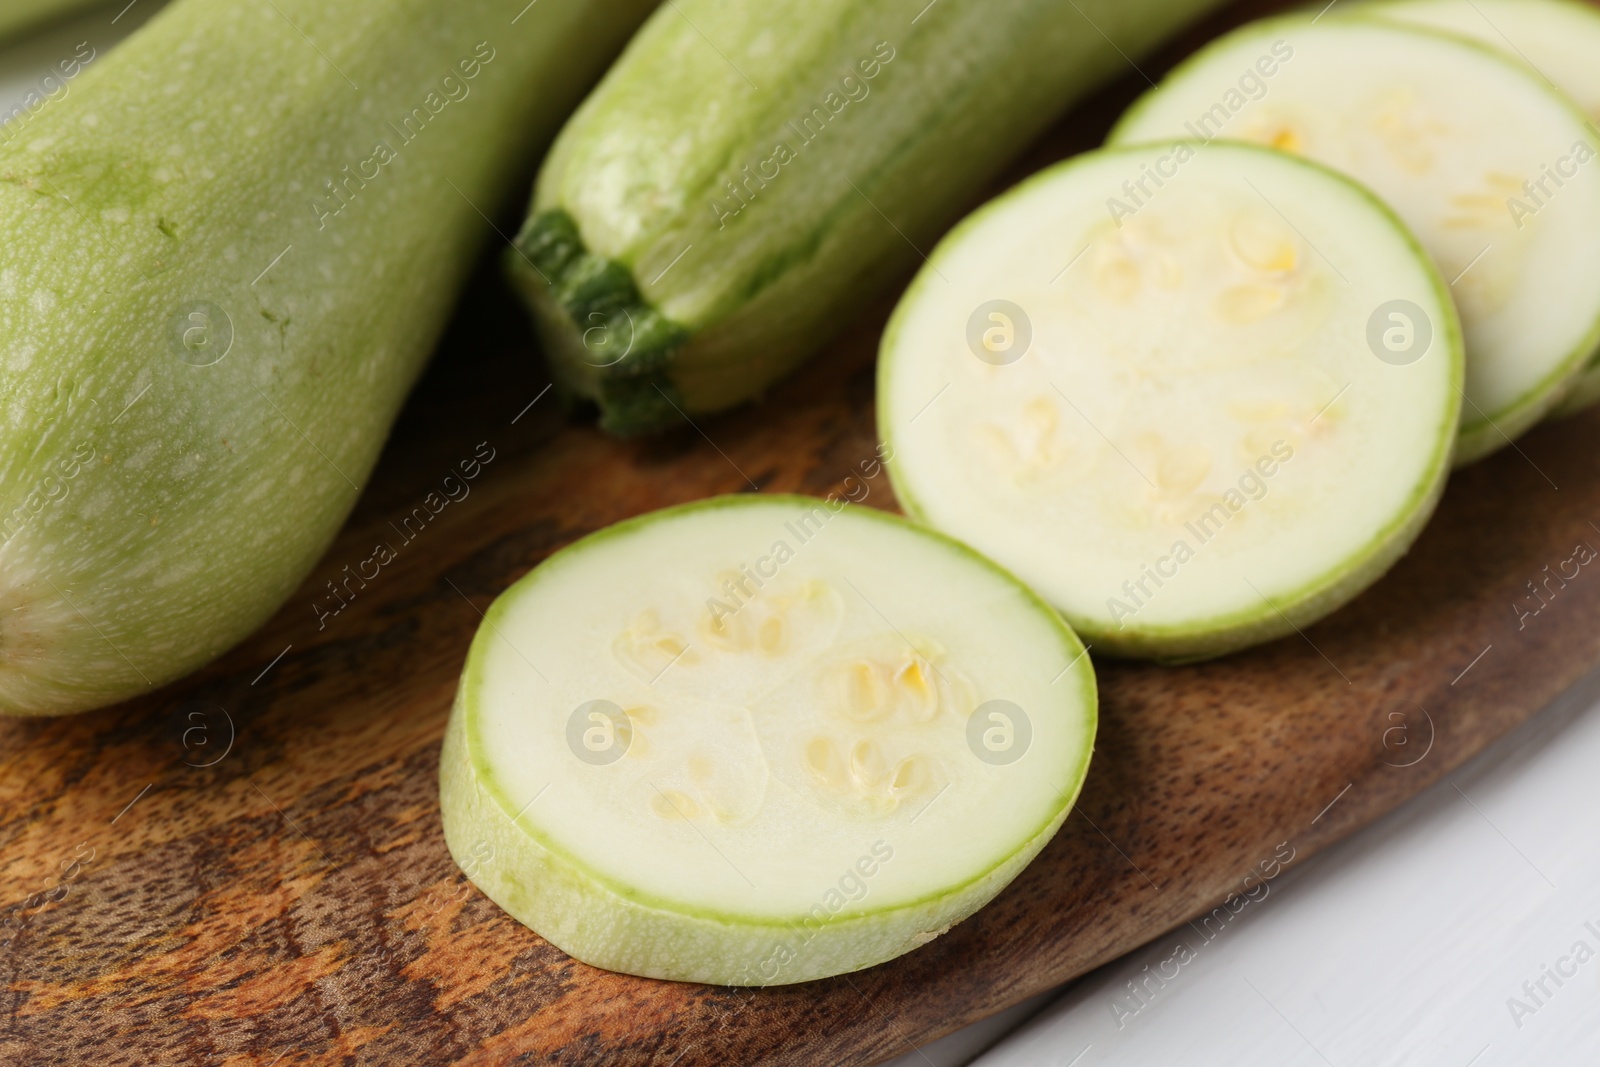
0 0 651 715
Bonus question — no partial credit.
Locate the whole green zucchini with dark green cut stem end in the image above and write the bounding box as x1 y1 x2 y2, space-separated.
506 0 1216 435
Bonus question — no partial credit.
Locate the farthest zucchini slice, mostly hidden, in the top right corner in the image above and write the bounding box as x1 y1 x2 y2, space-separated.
1362 0 1600 418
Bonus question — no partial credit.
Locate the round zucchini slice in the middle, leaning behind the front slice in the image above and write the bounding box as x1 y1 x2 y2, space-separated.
878 144 1462 659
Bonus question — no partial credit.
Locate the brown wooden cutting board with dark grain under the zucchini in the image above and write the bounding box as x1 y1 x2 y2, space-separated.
0 5 1600 1067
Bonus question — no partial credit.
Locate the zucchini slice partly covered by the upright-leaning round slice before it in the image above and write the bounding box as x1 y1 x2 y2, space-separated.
1112 16 1600 464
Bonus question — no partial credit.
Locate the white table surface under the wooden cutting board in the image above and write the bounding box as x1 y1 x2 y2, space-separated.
12 8 1600 1067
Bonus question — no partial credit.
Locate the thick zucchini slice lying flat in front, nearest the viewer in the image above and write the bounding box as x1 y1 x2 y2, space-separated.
440 496 1096 985
